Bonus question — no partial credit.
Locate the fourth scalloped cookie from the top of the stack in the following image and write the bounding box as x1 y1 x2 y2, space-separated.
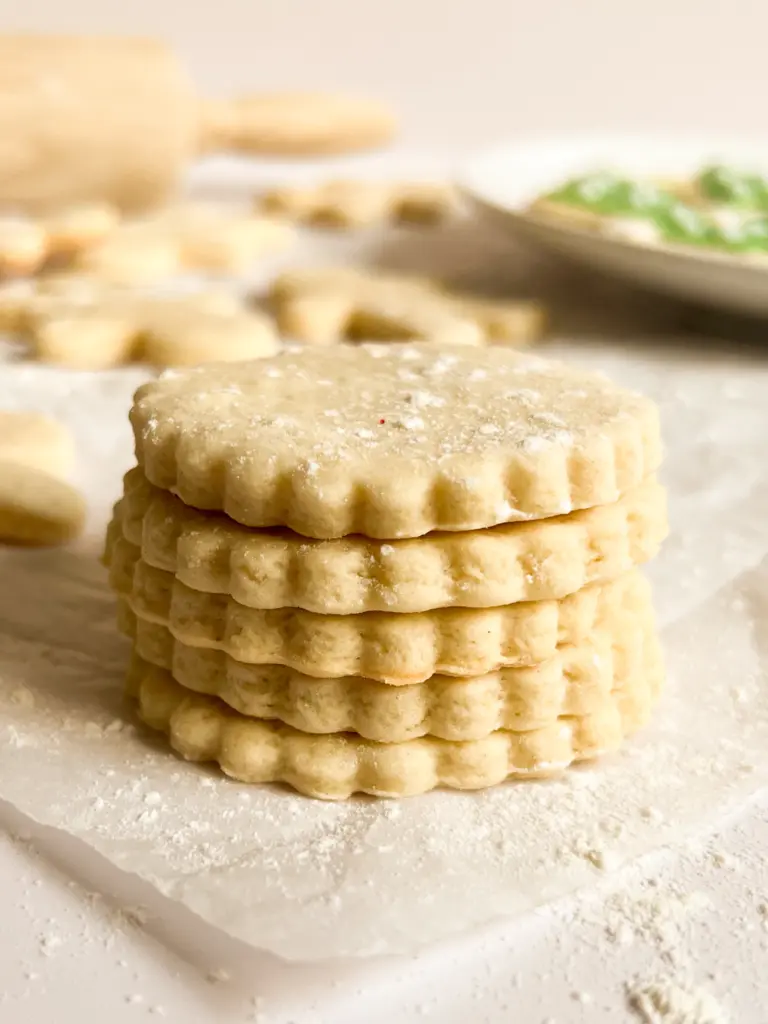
123 612 660 742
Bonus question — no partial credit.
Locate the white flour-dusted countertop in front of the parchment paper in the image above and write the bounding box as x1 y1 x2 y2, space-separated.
0 800 768 1024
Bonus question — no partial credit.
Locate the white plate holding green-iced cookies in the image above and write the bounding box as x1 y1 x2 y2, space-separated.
460 135 768 315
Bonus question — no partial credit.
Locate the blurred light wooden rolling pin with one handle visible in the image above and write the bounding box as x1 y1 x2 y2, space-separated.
0 35 394 213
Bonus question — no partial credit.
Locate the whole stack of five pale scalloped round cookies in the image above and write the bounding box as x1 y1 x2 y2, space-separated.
106 344 667 799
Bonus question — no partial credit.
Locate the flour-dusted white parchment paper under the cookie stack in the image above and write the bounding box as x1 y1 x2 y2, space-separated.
0 172 768 959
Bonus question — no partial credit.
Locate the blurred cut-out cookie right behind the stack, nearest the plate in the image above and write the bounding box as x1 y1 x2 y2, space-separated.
268 267 545 346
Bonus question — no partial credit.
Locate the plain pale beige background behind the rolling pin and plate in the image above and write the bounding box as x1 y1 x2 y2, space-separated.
0 0 768 151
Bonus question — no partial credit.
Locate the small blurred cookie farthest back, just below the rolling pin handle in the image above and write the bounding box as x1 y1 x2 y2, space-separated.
257 180 459 228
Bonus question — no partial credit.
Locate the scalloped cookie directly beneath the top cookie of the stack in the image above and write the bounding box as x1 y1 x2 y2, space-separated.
116 469 667 615
